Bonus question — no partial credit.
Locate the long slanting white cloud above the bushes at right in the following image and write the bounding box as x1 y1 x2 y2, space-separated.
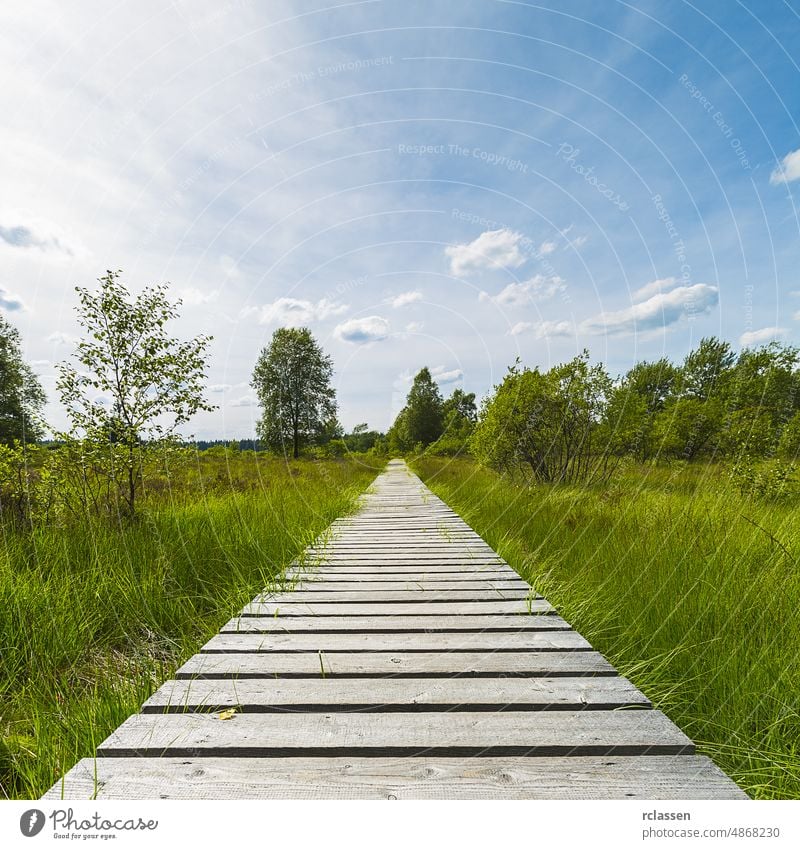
580 283 719 336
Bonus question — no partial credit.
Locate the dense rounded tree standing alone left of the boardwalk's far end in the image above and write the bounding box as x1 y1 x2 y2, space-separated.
251 327 336 459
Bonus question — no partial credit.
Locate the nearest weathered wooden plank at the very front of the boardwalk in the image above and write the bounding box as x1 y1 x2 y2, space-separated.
44 755 747 801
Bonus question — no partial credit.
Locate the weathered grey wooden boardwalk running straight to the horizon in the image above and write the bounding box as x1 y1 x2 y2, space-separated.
45 460 746 799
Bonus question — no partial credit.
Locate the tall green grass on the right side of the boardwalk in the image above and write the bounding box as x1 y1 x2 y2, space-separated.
414 459 800 799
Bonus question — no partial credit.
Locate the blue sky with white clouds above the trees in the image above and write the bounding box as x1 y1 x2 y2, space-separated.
0 0 800 438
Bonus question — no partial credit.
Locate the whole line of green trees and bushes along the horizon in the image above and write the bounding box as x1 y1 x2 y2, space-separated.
0 271 800 515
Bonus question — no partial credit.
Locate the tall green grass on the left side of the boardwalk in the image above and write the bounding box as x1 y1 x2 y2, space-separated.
0 451 383 798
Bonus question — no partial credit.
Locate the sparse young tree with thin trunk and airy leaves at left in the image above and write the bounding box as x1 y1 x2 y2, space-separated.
56 271 215 516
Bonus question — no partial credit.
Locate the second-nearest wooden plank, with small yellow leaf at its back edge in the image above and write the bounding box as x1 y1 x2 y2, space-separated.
97 710 694 758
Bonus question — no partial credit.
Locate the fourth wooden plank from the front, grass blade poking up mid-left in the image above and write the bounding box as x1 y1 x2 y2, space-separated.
175 651 616 679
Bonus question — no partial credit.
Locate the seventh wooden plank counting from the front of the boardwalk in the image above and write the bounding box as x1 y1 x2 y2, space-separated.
241 598 555 618
